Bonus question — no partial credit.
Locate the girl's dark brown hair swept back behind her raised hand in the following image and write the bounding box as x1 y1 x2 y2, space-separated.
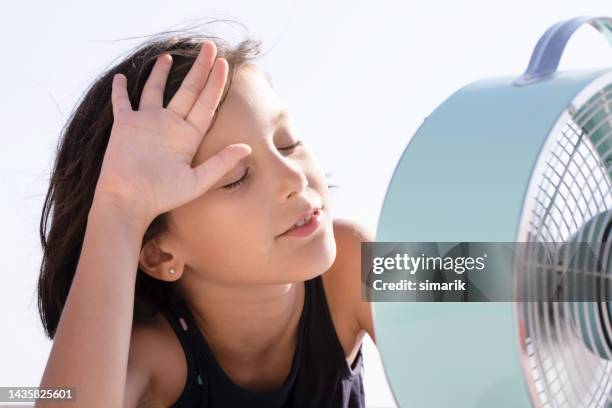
37 23 262 339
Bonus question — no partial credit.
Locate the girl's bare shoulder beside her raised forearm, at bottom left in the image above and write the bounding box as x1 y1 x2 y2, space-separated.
124 313 187 408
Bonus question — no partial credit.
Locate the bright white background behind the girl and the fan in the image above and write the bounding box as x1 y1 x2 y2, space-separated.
0 0 612 407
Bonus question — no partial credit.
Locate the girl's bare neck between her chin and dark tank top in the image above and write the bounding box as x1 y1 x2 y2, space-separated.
180 282 305 366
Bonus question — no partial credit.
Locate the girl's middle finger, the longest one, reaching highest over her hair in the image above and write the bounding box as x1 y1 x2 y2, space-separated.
167 40 217 118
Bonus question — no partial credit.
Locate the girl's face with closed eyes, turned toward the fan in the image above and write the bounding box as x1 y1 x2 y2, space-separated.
160 64 336 286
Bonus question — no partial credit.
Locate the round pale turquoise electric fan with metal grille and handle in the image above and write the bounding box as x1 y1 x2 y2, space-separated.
373 17 612 408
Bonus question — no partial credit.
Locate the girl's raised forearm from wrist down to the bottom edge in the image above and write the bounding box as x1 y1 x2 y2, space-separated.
37 196 146 407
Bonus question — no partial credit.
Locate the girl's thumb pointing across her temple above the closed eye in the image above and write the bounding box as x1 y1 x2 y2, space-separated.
193 143 252 196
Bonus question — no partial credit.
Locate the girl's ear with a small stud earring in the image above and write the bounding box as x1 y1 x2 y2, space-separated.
138 237 185 282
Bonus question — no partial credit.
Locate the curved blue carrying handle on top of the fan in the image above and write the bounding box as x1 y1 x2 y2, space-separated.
513 17 612 86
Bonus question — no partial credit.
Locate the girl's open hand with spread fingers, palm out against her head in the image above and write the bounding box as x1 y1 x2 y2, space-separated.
96 41 251 222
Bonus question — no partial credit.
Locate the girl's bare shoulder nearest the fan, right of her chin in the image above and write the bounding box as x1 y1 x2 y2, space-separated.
323 219 376 355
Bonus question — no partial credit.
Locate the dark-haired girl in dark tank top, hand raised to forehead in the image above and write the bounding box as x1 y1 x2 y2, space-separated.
37 27 375 408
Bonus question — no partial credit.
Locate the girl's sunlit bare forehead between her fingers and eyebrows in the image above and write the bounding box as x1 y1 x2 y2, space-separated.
196 64 283 163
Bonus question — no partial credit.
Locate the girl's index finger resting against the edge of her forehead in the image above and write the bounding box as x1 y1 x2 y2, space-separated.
185 58 229 134
